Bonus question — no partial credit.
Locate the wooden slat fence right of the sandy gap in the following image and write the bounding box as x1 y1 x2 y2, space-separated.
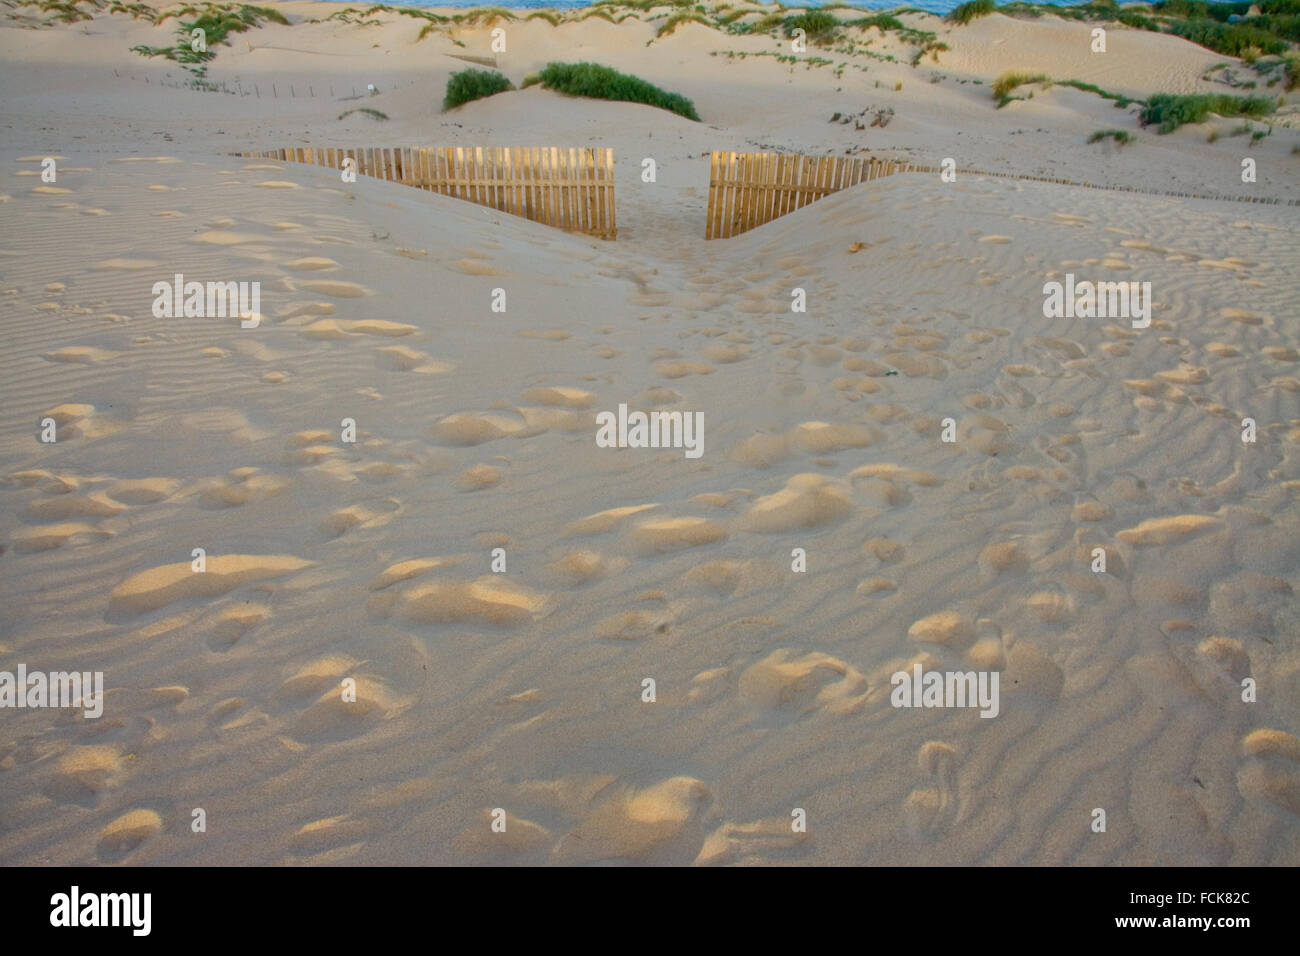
705 151 915 239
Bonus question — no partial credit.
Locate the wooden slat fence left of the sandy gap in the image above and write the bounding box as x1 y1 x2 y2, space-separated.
237 146 618 239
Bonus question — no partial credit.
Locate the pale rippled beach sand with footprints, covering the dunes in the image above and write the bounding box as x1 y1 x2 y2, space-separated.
0 3 1300 865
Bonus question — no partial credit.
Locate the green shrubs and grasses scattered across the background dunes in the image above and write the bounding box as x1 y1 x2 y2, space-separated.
40 0 1300 118
